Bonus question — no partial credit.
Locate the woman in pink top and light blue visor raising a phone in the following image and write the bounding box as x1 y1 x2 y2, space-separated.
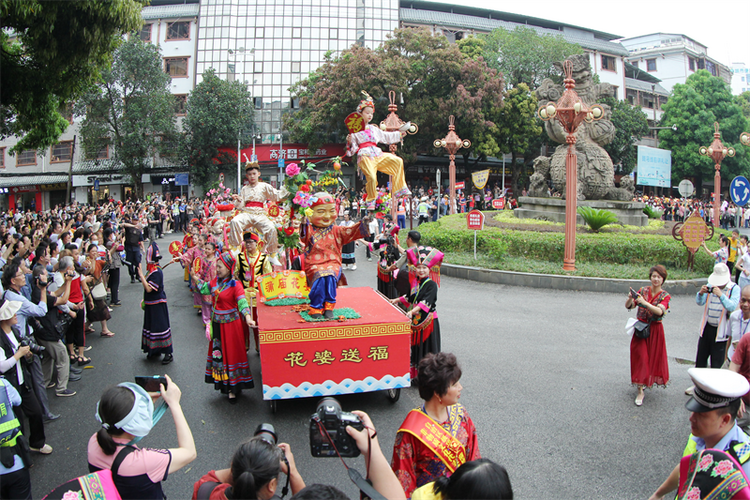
88 375 197 500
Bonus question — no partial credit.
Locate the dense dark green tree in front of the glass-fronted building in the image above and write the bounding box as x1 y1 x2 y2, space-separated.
181 68 254 187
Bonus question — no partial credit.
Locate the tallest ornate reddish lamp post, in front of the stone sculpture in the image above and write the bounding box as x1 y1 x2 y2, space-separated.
537 60 604 271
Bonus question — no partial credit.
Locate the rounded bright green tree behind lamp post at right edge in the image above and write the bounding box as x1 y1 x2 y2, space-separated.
659 70 750 193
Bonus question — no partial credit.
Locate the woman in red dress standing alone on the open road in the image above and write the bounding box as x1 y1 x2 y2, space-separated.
625 264 671 406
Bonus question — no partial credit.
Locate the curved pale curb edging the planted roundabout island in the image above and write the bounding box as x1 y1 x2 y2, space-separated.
440 263 705 295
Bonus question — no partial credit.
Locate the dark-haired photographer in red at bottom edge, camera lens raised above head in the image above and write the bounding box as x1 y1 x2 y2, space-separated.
192 424 305 500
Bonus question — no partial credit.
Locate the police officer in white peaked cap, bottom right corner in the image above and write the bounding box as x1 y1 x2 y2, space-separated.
649 368 750 500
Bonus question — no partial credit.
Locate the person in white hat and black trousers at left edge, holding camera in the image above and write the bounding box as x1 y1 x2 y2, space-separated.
0 299 52 455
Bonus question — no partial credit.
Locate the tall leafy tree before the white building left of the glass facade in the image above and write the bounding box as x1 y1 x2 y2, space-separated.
75 36 177 196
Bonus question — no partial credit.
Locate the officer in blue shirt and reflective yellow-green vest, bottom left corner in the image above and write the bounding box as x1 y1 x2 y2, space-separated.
0 377 31 500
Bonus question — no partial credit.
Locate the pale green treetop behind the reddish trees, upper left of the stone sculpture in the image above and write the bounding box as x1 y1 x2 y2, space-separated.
472 26 583 89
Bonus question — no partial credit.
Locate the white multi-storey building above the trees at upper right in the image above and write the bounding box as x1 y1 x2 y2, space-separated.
620 33 732 92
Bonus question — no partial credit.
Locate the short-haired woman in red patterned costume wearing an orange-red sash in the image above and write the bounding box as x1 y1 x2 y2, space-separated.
391 352 481 498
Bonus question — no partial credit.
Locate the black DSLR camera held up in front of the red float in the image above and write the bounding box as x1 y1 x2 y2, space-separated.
310 397 365 458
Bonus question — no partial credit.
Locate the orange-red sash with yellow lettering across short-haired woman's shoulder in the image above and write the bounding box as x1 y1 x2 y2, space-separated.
398 404 466 474
